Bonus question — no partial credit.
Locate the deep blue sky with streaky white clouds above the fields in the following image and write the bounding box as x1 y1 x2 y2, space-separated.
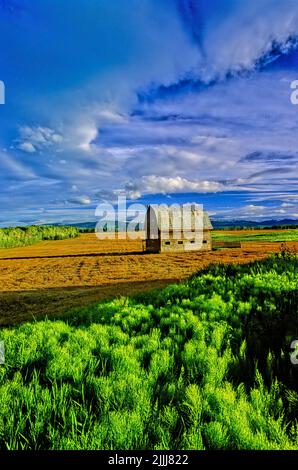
0 0 298 226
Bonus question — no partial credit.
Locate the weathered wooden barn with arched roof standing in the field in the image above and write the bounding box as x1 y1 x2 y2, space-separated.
144 204 213 253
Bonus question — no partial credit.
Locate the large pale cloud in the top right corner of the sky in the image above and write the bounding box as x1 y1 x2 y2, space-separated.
190 0 298 81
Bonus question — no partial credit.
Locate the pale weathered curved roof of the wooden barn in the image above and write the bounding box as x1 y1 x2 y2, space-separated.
147 204 213 231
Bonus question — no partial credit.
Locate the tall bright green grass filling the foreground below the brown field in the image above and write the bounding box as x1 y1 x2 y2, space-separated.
0 253 298 450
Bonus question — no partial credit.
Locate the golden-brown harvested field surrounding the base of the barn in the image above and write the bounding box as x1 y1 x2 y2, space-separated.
0 231 298 325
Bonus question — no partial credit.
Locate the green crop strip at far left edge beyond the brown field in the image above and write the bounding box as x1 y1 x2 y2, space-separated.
0 225 79 248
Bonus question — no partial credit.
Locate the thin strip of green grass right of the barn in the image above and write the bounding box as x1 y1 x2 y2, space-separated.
212 229 298 242
